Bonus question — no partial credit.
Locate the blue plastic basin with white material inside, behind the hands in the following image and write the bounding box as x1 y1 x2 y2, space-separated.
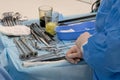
55 21 95 40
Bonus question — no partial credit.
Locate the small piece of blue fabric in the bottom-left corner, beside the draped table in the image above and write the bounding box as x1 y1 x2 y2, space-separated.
0 65 12 80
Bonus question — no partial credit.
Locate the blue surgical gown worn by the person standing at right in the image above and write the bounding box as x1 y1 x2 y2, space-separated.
83 0 120 80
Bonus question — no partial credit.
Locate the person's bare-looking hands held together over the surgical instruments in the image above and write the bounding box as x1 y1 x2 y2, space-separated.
66 32 90 64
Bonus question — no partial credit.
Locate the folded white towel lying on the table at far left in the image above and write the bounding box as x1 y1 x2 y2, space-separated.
0 25 30 36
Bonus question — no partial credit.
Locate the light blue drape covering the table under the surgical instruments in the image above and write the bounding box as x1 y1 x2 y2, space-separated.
0 35 92 80
